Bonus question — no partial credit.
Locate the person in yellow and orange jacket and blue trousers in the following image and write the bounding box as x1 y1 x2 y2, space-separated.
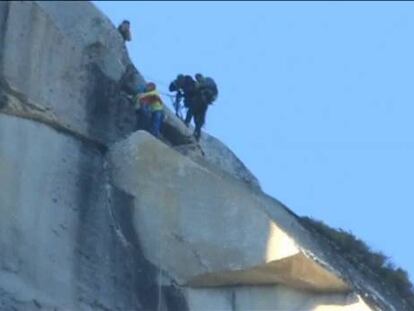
135 82 164 137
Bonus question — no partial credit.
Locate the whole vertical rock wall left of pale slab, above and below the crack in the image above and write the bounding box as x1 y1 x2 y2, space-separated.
0 2 158 310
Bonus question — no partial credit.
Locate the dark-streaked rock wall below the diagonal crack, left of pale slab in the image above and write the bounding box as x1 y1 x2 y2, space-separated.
0 115 154 310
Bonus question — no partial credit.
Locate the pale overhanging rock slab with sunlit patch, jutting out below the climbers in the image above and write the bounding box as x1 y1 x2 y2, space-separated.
109 131 347 291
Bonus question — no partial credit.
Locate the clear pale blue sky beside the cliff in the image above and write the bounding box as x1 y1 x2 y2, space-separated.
95 1 414 279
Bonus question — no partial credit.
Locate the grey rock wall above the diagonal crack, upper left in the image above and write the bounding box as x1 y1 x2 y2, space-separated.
0 1 140 143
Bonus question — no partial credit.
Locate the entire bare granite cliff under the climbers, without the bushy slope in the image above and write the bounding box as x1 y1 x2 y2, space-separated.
0 1 409 311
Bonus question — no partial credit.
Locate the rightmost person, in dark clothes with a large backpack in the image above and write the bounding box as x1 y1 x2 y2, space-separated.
184 74 218 141
